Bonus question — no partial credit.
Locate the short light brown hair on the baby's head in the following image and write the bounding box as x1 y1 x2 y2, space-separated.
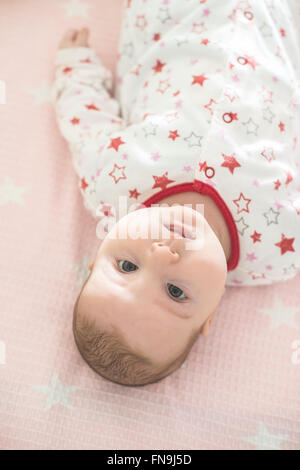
73 300 200 386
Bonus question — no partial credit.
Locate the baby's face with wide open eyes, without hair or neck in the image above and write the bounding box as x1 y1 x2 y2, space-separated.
78 205 227 365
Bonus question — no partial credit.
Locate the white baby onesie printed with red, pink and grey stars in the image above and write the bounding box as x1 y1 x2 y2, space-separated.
52 0 300 286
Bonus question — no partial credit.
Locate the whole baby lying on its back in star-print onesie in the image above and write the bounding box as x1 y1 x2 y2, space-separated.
53 0 300 385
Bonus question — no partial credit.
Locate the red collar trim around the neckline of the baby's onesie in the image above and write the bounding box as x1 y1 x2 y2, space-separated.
141 180 240 271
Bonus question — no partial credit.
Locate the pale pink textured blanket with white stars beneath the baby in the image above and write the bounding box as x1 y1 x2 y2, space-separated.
0 0 300 449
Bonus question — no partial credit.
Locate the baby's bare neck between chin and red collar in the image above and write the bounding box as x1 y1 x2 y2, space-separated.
156 191 231 262
